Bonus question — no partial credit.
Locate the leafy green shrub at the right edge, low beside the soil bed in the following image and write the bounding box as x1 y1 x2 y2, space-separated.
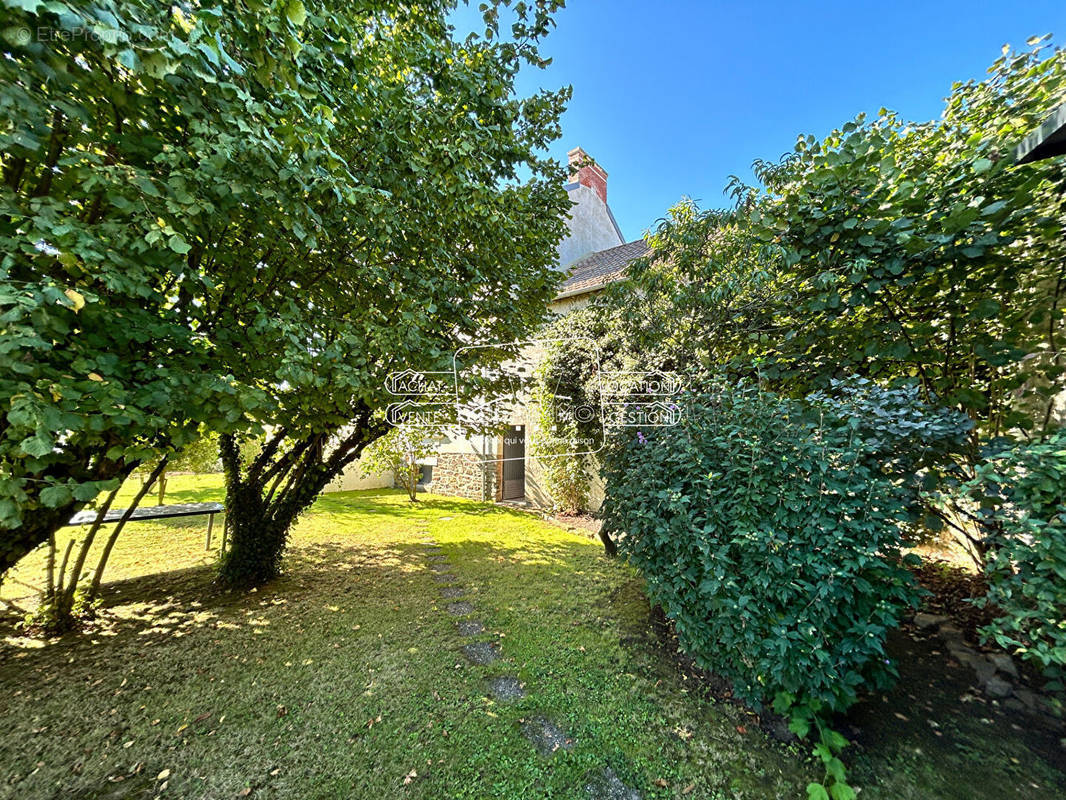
967 430 1066 676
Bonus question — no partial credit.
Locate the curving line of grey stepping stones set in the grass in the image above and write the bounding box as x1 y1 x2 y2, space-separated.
415 529 641 800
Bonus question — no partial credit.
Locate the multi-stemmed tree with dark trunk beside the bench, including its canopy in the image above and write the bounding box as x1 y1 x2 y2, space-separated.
210 2 568 586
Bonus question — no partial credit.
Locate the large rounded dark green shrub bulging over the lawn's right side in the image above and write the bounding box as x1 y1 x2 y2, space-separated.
603 385 919 710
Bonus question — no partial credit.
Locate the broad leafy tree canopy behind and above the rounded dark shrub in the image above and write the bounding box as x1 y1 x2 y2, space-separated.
629 39 1066 436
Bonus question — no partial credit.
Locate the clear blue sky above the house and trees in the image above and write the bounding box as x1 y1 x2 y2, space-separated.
455 0 1066 239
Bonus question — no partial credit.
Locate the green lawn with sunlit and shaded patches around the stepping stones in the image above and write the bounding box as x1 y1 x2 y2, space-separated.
0 476 1062 800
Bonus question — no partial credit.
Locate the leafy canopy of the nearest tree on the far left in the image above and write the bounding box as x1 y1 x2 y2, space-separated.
0 0 372 571
